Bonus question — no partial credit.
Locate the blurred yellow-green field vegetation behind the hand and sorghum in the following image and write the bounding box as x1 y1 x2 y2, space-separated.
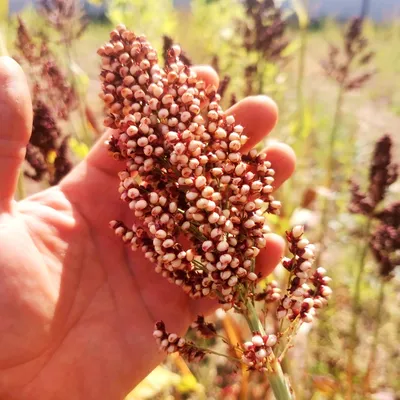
0 0 400 400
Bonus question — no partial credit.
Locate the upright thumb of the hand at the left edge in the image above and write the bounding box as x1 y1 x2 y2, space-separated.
0 57 32 212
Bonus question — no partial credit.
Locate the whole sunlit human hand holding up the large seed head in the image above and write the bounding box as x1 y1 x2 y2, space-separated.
0 58 295 400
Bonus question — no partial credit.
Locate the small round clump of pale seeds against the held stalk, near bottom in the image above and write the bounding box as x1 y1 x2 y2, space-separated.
242 332 277 372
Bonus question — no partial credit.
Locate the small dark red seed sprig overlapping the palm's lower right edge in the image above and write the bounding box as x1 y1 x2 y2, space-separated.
153 321 206 362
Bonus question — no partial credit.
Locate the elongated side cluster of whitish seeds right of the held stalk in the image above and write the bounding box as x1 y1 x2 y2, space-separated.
277 226 332 322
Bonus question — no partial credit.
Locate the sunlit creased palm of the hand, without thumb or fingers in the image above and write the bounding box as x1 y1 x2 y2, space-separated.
0 167 214 398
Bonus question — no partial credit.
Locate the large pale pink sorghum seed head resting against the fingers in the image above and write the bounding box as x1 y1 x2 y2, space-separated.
99 25 280 308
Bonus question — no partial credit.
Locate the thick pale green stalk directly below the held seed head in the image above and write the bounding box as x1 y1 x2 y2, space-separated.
246 301 293 400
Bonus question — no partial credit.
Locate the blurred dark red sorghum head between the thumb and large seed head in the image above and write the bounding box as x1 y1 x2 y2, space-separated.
16 19 77 185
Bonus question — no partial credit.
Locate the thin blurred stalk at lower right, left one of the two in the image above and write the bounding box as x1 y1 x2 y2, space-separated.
347 217 372 399
